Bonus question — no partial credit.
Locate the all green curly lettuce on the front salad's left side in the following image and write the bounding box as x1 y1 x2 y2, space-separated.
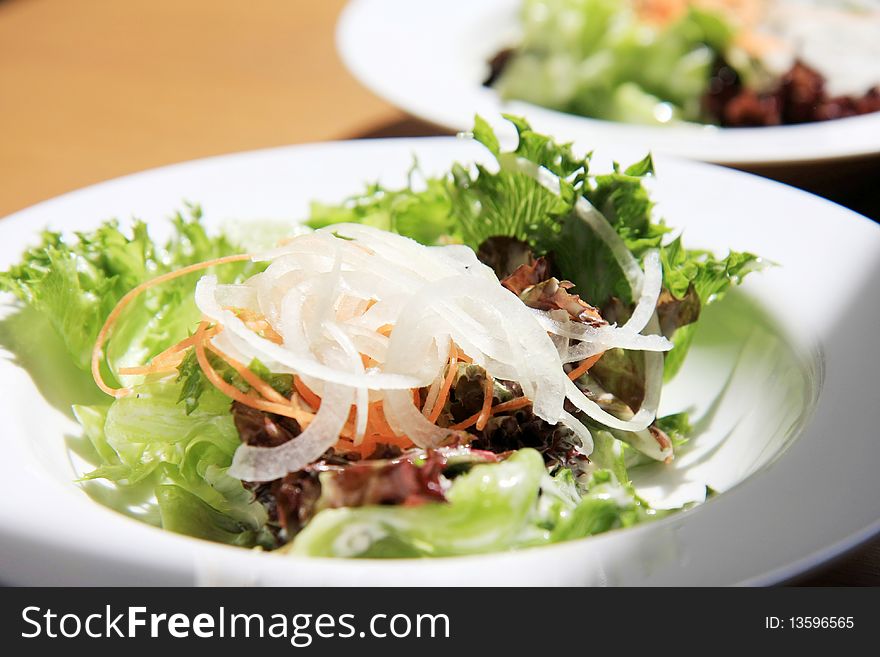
0 206 272 545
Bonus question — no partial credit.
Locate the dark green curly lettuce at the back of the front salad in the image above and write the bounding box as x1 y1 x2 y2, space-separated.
307 115 763 380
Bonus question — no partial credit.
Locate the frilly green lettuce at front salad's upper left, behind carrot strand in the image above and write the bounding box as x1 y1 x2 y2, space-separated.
0 206 257 380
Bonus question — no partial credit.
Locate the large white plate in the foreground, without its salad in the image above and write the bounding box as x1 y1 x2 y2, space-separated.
0 138 880 585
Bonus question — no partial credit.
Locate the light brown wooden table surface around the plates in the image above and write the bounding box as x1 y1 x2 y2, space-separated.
0 0 880 585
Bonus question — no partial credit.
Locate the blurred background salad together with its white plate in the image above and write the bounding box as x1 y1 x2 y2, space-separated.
337 0 880 163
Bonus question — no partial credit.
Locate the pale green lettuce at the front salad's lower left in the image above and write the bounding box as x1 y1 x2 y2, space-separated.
75 380 268 545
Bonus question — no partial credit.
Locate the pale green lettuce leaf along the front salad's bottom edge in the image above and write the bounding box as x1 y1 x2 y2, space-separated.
288 448 656 558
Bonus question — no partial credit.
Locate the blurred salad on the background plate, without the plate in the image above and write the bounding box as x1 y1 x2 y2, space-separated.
487 0 880 127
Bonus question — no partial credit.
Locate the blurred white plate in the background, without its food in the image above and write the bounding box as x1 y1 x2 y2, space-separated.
337 0 880 166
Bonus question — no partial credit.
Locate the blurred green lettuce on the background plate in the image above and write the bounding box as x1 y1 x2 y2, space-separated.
494 0 733 124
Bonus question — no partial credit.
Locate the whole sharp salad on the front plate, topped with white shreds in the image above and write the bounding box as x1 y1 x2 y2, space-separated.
0 117 761 557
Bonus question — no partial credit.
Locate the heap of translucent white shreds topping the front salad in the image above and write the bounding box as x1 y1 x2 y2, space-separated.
196 215 671 481
